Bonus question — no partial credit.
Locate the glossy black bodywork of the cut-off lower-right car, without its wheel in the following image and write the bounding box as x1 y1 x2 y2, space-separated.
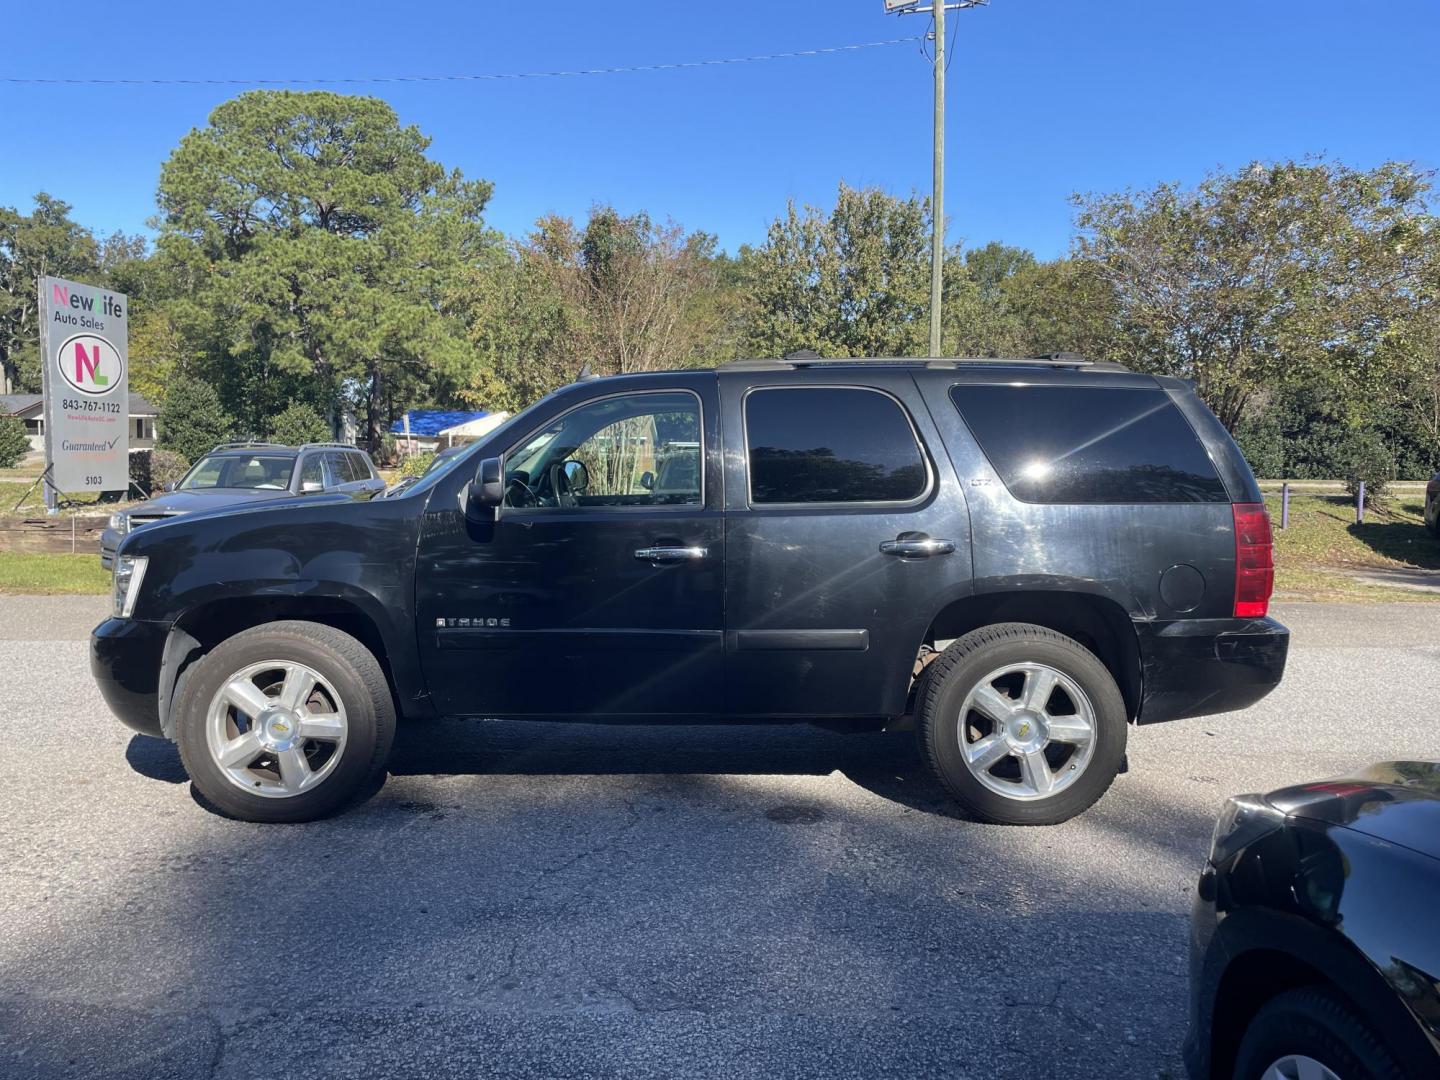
1185 762 1440 1080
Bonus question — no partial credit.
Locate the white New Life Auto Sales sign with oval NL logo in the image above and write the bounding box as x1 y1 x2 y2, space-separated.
40 278 130 491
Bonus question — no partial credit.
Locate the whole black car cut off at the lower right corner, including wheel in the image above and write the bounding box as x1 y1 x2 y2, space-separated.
1185 762 1440 1080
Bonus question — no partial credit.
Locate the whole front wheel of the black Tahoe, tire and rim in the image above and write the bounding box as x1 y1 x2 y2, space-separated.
176 622 395 822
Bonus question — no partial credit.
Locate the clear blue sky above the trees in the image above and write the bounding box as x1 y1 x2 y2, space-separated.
0 0 1440 258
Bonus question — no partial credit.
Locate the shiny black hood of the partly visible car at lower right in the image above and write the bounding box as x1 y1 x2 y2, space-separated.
1266 762 1440 858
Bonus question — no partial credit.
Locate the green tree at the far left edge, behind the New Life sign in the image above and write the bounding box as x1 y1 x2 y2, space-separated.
0 192 104 393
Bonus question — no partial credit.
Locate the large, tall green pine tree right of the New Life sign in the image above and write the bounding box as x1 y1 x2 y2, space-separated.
158 91 495 445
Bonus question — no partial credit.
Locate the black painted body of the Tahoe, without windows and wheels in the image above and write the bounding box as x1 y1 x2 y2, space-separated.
94 363 1287 723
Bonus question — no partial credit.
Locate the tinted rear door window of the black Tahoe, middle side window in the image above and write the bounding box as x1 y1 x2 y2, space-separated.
744 386 926 505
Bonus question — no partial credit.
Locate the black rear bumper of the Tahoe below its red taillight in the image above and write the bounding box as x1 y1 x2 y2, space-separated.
1135 619 1290 724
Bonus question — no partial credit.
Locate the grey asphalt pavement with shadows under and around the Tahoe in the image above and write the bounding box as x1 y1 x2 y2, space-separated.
0 598 1440 1080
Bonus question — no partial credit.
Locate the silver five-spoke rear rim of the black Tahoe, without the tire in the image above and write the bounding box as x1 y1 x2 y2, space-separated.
959 662 1096 802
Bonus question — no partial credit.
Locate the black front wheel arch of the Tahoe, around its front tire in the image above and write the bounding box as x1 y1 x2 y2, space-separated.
158 595 429 739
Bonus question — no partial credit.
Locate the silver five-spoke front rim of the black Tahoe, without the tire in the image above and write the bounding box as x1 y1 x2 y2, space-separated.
204 660 347 799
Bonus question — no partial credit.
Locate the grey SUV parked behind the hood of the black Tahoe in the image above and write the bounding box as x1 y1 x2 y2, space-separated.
99 442 384 570
